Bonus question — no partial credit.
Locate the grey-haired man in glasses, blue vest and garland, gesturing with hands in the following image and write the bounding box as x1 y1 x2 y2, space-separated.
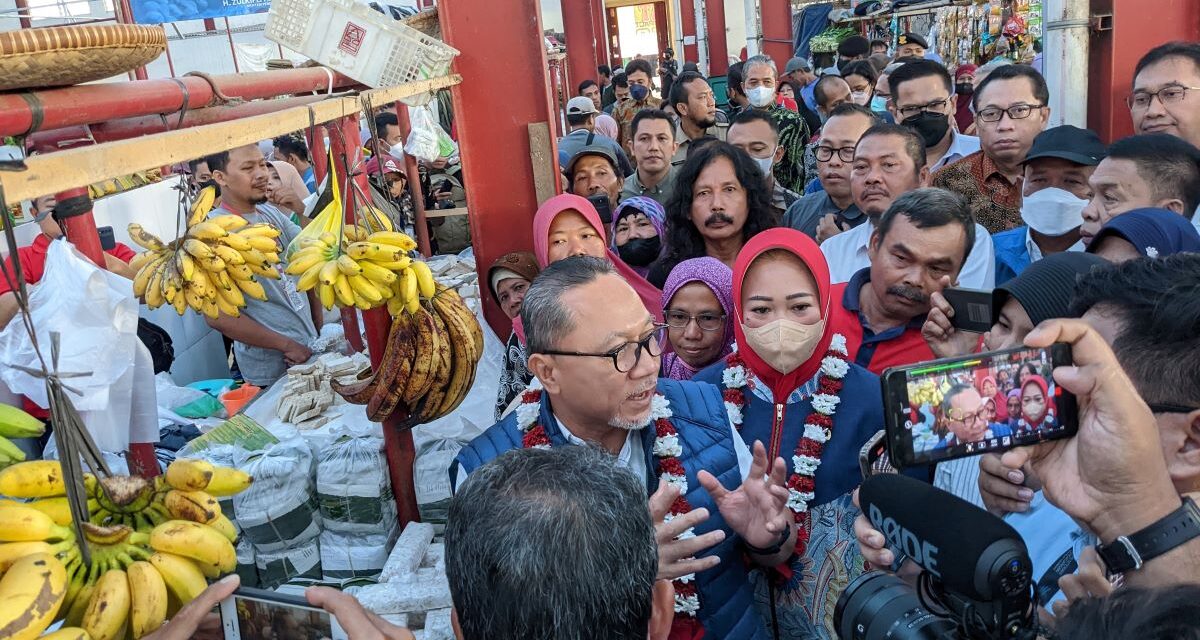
451 256 797 640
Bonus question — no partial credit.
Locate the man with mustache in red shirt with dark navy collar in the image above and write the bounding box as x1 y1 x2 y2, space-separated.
829 189 990 373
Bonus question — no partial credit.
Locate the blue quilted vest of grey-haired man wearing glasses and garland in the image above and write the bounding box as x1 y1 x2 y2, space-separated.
450 378 768 640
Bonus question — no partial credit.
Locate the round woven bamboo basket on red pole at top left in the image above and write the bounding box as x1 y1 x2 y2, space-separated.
0 24 167 91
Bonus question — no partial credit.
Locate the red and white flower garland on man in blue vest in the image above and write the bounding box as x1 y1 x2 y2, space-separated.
516 389 700 617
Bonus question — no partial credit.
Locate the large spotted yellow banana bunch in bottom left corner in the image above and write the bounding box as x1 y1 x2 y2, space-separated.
0 460 252 640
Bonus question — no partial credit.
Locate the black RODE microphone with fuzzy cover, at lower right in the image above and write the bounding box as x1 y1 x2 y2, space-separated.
858 473 1033 602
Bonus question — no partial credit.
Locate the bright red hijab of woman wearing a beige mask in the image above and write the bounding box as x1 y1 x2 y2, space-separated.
733 227 833 402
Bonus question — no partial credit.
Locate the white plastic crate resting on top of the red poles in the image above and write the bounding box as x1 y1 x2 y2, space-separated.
266 0 458 98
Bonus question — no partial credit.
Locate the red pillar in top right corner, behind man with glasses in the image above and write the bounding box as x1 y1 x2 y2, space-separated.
1087 0 1200 142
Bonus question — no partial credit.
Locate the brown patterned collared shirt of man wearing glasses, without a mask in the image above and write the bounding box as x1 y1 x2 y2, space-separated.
931 150 1021 233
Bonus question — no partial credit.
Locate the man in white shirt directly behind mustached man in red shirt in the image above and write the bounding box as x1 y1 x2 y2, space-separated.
821 125 996 289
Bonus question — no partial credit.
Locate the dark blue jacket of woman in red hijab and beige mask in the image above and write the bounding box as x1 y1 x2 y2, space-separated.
692 359 883 508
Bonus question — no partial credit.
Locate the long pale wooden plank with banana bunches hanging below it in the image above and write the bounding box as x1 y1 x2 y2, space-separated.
0 76 462 202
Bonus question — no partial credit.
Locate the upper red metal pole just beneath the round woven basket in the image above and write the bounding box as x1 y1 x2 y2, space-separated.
0 67 358 136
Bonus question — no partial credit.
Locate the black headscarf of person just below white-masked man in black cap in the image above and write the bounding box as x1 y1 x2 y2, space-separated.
991 251 1109 325
